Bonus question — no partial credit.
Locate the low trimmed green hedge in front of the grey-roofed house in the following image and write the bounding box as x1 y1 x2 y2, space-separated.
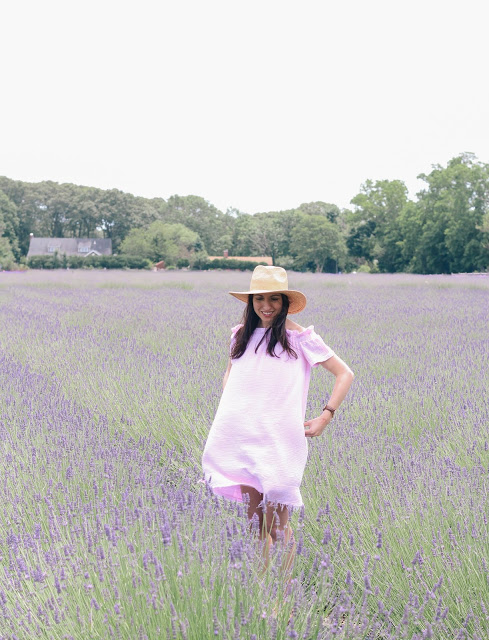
27 253 151 269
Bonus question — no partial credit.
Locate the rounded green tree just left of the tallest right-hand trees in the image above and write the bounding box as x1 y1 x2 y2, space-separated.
292 215 347 272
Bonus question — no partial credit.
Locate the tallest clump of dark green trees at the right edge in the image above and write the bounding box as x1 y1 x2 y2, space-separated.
347 154 489 273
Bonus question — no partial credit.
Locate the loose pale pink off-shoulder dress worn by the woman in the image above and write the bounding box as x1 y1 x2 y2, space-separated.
202 325 334 507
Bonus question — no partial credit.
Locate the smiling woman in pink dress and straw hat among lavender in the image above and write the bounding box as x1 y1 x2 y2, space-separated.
202 266 353 556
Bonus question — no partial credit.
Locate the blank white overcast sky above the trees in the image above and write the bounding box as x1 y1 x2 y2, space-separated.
0 0 489 213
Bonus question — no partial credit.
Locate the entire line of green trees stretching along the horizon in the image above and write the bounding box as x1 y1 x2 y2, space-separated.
0 153 489 274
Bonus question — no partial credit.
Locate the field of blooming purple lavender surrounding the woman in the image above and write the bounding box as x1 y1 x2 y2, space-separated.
0 271 489 640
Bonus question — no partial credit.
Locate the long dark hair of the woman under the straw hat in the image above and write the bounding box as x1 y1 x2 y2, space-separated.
231 293 297 360
